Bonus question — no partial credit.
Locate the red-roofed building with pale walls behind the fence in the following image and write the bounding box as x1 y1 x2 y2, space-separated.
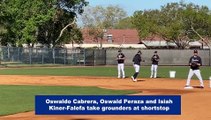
79 29 206 48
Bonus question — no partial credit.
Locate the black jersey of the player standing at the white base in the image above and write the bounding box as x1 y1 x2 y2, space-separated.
189 55 202 70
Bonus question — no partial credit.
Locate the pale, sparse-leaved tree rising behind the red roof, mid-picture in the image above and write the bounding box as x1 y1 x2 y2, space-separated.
82 5 127 29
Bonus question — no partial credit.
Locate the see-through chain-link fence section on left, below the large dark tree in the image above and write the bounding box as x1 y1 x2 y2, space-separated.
0 47 106 65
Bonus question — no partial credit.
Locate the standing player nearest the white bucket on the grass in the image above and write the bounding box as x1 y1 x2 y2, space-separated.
150 51 160 78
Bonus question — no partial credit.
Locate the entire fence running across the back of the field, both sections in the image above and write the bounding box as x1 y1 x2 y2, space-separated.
0 47 208 66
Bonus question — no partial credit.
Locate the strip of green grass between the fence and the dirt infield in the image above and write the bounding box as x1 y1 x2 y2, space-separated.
0 66 211 80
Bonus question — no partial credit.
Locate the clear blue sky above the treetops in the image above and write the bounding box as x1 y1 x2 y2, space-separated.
86 0 211 16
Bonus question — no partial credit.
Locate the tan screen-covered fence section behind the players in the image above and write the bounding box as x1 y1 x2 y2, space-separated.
106 49 211 66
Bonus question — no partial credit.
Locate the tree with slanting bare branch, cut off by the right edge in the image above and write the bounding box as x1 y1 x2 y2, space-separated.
183 3 211 46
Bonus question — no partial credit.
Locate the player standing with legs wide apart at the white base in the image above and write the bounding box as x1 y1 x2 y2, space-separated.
185 50 204 88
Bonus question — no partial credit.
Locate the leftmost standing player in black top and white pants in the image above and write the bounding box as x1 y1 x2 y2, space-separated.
117 50 125 78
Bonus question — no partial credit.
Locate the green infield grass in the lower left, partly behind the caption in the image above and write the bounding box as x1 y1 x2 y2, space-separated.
0 85 136 116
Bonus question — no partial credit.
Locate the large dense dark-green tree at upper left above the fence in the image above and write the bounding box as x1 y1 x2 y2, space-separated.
0 0 88 46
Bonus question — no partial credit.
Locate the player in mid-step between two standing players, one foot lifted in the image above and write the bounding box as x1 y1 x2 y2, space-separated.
131 50 142 82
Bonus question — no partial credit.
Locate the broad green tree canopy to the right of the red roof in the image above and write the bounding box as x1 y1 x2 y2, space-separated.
133 1 211 49
